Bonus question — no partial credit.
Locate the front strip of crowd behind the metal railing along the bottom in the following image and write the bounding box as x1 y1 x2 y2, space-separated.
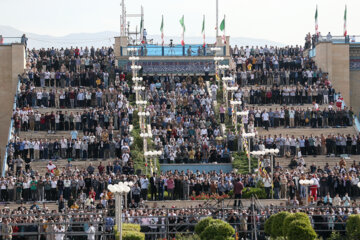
0 201 359 240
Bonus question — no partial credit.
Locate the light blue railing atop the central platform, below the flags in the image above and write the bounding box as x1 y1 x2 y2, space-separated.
120 44 226 57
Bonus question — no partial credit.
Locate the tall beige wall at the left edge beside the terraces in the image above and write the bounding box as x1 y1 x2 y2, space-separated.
0 44 25 172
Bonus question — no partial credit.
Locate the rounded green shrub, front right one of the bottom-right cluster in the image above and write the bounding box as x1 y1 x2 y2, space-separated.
286 220 317 240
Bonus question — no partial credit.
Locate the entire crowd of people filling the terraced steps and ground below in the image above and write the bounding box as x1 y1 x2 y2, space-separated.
0 40 360 239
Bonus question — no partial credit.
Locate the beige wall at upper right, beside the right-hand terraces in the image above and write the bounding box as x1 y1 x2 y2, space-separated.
314 42 351 105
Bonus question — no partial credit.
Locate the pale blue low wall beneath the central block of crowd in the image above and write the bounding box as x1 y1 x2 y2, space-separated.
160 163 233 173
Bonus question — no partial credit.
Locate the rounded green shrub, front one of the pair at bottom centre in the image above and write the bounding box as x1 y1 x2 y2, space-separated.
200 219 235 240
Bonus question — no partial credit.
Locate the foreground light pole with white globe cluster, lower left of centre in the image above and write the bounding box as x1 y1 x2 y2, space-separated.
108 182 134 240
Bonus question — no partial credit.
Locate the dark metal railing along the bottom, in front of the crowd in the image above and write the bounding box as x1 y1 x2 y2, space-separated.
0 204 347 239
